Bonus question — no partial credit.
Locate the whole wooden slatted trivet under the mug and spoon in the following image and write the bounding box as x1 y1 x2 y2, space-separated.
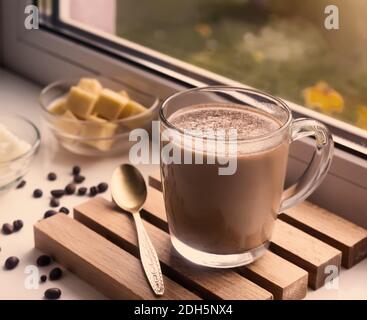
34 171 367 299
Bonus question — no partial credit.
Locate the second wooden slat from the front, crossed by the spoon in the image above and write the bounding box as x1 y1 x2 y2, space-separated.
74 198 272 300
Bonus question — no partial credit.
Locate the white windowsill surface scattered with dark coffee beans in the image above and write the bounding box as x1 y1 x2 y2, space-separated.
0 69 367 300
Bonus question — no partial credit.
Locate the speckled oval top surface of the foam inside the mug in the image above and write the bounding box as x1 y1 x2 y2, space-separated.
169 104 280 139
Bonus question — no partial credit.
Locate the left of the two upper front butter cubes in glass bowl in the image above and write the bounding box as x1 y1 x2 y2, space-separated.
65 87 97 119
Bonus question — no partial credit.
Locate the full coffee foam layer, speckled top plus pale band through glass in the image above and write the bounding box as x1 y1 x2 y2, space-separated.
168 103 283 154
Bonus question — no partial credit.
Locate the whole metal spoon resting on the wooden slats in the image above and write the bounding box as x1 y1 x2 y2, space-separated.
111 164 164 295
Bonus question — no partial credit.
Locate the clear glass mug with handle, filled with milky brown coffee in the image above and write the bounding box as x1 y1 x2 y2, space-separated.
160 86 334 268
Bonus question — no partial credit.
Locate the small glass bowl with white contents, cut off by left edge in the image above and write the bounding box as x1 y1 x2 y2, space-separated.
0 115 41 192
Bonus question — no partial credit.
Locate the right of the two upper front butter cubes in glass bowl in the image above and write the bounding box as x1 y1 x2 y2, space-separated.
95 89 129 121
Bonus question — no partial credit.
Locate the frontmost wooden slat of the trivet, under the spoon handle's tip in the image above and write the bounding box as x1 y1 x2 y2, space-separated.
34 213 199 299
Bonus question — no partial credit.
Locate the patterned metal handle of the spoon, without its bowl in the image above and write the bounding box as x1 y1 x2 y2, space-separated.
133 212 164 296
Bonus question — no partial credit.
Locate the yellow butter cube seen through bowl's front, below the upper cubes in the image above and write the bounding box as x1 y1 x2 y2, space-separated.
82 116 117 151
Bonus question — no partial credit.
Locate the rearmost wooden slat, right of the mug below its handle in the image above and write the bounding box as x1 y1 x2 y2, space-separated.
280 201 367 268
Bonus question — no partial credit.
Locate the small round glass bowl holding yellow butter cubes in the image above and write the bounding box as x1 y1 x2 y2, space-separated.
39 77 159 156
